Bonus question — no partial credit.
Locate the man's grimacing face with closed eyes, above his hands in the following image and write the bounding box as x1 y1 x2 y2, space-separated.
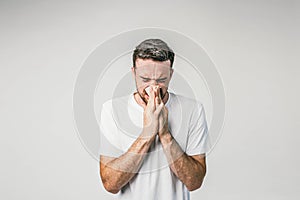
131 58 173 103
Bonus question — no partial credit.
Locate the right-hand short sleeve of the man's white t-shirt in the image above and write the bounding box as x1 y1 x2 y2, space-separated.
186 102 209 155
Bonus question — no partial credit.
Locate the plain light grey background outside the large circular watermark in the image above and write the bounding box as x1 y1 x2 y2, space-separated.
0 0 300 200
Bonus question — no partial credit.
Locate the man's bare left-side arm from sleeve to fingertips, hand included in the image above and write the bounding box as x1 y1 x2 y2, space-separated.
100 88 163 193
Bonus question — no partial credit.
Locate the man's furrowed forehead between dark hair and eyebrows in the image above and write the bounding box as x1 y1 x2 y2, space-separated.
135 58 171 74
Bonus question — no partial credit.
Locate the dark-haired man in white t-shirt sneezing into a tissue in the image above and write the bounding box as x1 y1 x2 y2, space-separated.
100 39 208 200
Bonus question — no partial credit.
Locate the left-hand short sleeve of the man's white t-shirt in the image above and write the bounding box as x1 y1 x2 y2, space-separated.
98 102 123 157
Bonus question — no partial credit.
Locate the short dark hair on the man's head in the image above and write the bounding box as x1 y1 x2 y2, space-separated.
132 39 175 67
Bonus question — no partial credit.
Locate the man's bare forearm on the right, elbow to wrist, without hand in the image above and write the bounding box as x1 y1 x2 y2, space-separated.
160 133 206 191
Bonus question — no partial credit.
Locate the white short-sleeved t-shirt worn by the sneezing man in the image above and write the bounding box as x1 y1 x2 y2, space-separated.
99 93 209 200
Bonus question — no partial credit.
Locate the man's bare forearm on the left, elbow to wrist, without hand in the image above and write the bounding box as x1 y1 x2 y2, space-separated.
100 133 155 193
